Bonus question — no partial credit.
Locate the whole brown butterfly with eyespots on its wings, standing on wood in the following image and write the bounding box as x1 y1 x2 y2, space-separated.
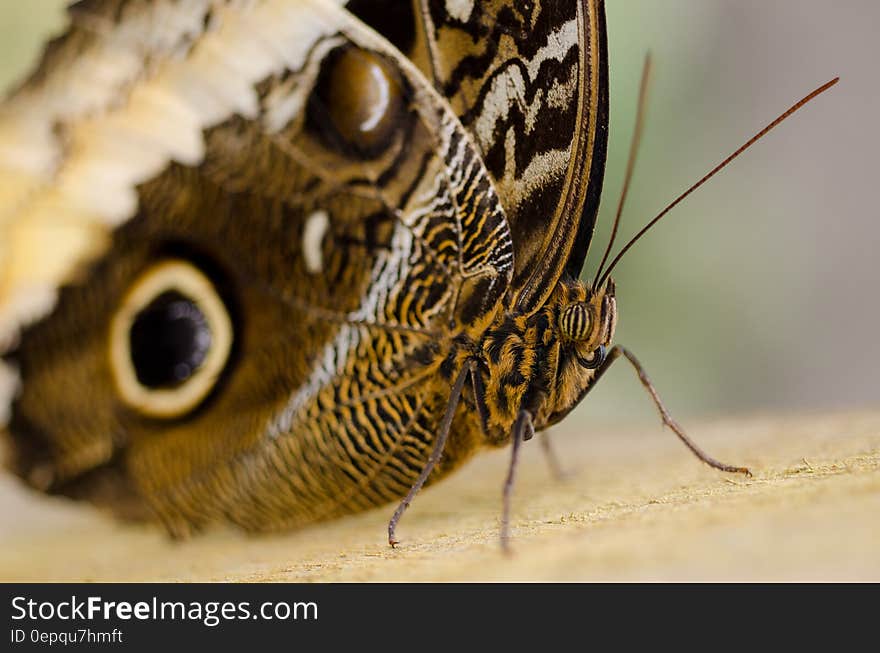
0 0 825 544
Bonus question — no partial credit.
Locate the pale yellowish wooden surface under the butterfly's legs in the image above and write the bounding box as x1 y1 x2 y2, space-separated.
0 412 880 581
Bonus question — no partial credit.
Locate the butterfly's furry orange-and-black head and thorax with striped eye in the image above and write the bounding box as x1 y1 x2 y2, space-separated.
478 279 617 444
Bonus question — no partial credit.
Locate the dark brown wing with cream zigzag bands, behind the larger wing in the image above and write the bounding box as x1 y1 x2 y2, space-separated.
347 0 608 312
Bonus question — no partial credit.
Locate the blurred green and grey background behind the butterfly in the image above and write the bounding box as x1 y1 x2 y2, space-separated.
0 0 880 428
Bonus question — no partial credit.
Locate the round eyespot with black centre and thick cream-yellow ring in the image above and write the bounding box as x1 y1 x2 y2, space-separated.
110 260 233 418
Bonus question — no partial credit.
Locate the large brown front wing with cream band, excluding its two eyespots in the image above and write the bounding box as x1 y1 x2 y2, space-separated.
4 0 513 532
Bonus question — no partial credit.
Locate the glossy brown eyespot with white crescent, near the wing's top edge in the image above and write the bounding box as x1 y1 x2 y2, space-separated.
309 47 403 156
